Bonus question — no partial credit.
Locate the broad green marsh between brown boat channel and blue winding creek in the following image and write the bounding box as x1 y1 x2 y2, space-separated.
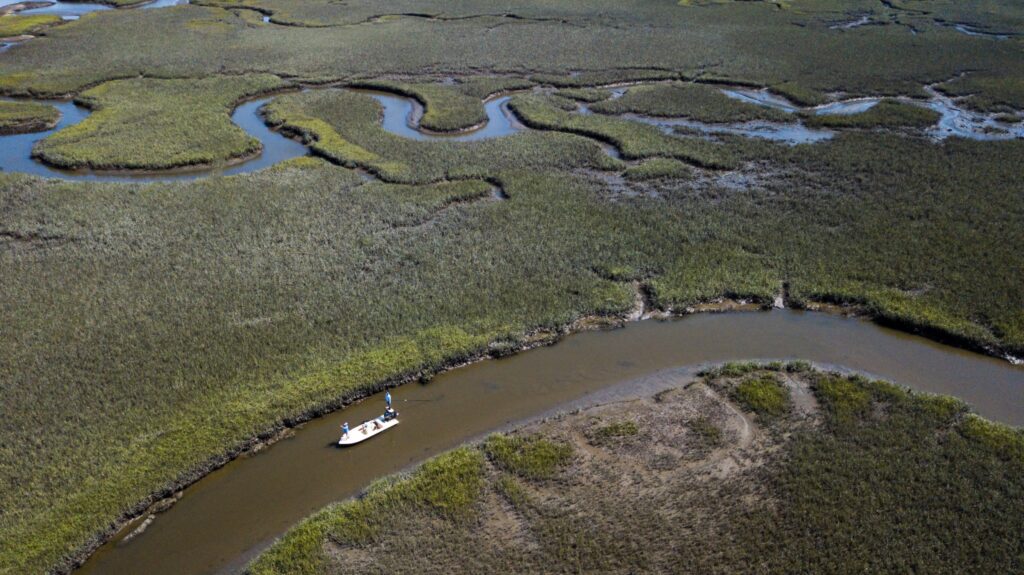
6 118 1024 571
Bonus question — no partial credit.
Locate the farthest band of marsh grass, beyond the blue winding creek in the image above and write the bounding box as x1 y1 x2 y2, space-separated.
0 0 1024 101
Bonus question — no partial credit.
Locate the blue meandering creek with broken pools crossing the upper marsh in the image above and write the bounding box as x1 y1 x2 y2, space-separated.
0 78 1024 182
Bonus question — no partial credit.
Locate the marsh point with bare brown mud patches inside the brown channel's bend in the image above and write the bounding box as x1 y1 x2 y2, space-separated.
249 362 1024 575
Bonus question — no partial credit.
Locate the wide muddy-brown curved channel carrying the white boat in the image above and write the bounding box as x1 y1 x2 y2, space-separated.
80 310 1024 575
